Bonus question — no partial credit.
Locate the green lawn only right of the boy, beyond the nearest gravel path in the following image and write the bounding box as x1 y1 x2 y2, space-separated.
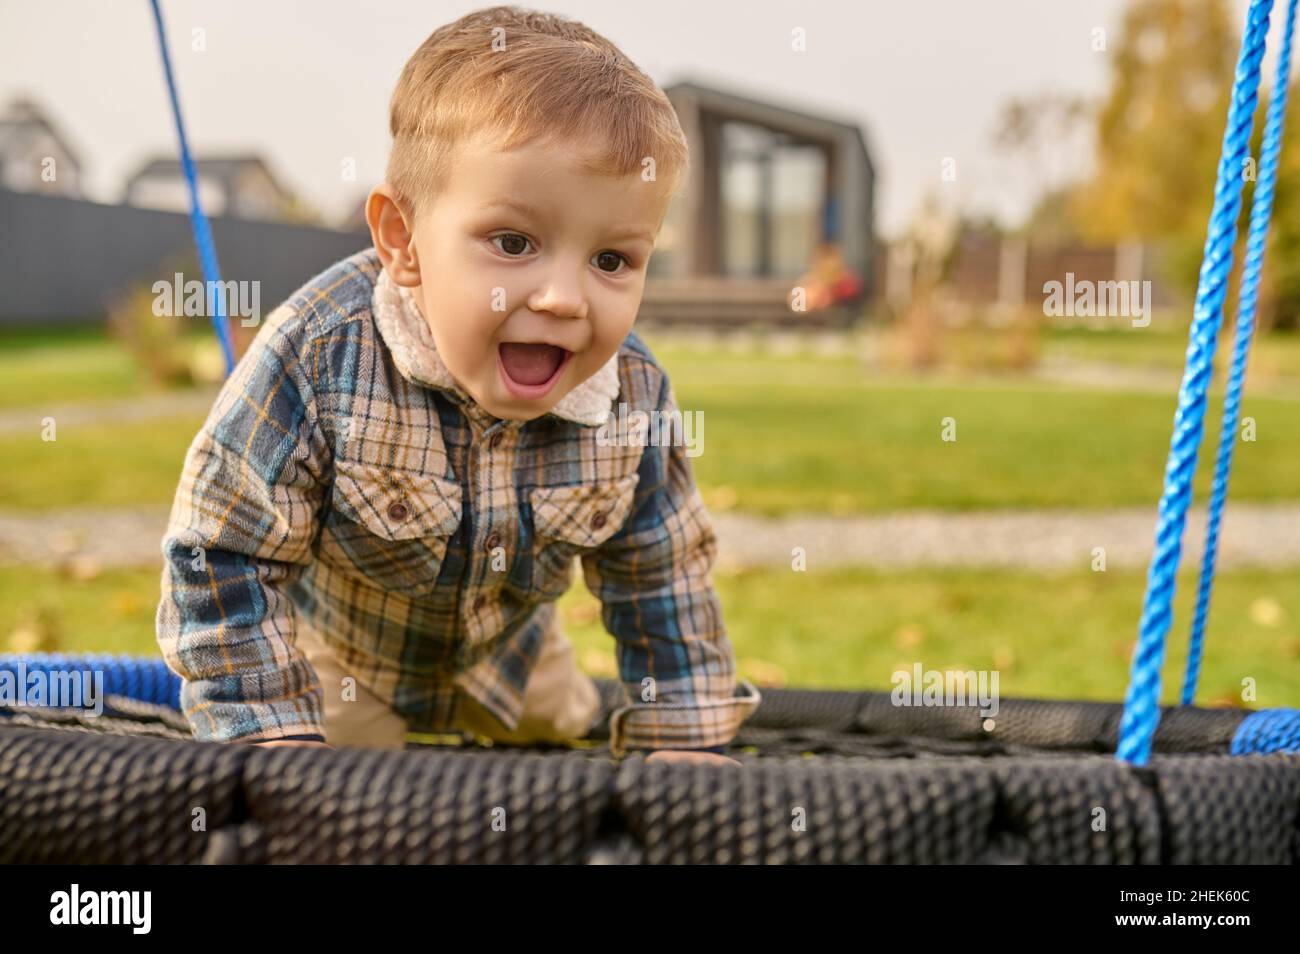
659 348 1300 513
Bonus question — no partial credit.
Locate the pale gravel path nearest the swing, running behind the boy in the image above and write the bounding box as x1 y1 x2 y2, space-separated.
0 503 1300 571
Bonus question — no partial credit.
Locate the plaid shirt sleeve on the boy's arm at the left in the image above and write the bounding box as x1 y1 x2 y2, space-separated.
156 307 329 742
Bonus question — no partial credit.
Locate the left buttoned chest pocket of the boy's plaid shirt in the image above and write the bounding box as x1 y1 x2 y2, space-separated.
329 460 462 597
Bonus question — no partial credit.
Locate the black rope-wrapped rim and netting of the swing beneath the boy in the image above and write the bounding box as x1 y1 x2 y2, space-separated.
0 682 1300 864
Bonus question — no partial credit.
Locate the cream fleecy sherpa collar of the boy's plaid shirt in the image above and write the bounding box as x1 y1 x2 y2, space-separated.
371 269 619 428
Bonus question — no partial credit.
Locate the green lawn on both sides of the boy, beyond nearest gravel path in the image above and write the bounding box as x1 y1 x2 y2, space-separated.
0 332 1300 515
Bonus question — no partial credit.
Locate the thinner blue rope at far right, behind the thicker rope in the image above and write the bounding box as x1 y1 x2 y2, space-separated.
1183 0 1296 706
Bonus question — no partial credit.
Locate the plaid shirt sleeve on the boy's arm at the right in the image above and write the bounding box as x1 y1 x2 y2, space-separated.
582 378 761 755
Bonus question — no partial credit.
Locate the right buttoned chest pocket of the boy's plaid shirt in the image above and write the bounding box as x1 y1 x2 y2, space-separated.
514 473 638 600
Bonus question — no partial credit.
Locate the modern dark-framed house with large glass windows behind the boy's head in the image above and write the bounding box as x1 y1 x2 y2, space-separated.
641 82 876 325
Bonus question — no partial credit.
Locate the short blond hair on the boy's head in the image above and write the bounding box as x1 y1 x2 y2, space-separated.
387 6 688 211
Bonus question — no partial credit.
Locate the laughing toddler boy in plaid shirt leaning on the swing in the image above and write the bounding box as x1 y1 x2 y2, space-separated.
157 6 758 762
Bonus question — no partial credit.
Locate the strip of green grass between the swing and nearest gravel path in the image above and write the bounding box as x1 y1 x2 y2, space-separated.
0 568 1300 707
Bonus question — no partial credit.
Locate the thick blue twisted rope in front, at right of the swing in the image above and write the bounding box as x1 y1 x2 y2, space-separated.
1115 0 1273 766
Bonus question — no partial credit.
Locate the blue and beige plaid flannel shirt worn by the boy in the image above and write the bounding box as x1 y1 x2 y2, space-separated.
157 250 759 754
